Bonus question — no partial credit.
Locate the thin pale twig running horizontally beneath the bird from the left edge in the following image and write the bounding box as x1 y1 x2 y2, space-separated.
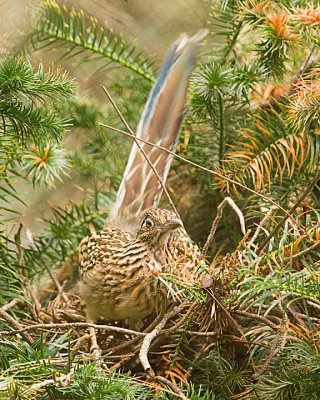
0 320 146 336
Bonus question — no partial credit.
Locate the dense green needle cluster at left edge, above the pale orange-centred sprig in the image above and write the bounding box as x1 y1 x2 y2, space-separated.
0 57 74 143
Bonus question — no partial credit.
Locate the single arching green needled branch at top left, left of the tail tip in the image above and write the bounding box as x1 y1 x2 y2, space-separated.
31 0 154 82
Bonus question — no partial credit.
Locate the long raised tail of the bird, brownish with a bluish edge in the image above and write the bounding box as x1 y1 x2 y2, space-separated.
107 30 207 231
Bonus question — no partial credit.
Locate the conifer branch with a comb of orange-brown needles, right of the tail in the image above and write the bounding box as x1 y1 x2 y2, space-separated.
216 108 319 193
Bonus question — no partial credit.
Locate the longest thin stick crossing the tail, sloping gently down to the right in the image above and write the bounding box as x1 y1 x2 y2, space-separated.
100 124 296 223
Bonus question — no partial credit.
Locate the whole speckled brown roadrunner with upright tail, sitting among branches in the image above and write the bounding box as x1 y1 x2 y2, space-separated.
78 30 207 357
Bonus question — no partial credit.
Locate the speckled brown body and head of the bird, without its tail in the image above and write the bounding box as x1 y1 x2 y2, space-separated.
79 208 184 327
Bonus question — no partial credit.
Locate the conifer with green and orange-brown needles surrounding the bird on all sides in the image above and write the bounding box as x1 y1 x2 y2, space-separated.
0 0 320 400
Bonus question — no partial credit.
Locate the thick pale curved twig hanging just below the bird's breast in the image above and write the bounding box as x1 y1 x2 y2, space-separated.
139 304 185 376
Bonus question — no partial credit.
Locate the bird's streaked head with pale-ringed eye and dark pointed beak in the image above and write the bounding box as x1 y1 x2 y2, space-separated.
138 208 183 244
